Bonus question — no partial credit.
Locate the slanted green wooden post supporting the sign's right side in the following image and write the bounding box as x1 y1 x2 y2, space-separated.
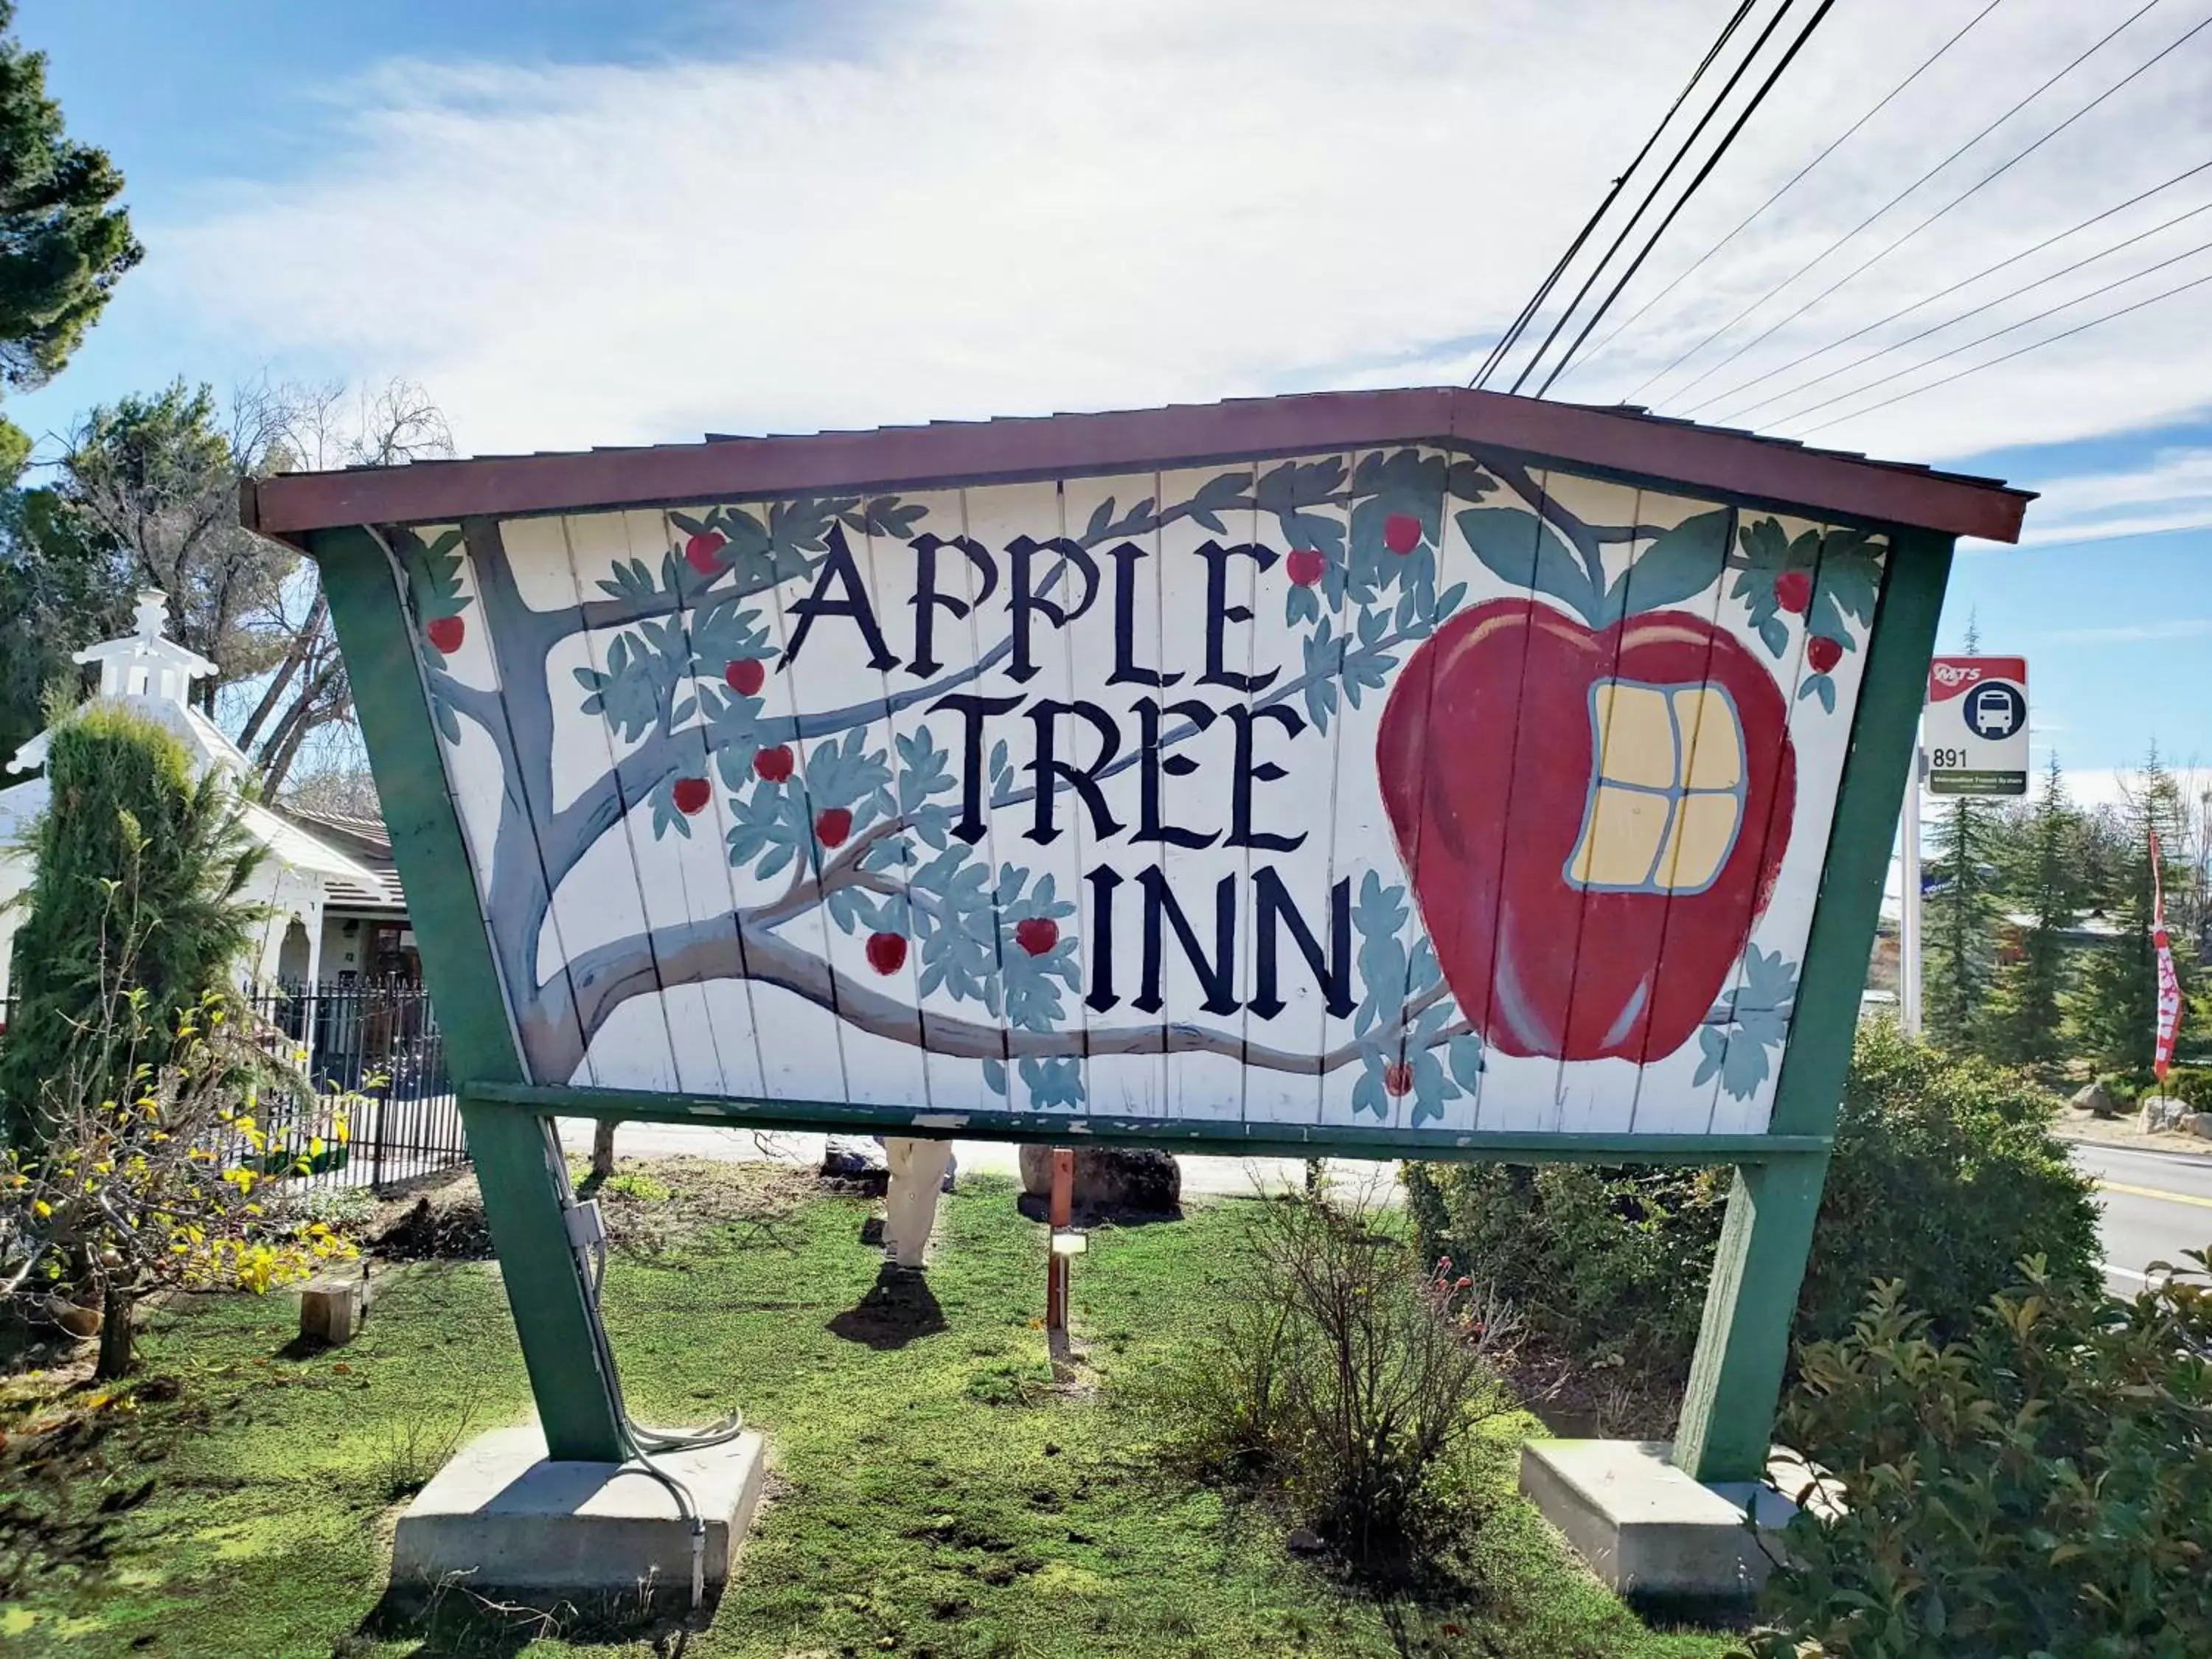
1674 533 1951 1482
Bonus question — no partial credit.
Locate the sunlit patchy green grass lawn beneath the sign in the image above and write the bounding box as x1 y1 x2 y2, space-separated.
0 1170 1734 1659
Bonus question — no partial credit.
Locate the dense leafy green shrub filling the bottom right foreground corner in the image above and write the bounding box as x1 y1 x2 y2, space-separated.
1754 1254 2212 1659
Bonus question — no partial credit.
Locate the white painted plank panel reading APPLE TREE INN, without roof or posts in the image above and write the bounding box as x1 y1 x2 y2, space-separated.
372 445 1889 1135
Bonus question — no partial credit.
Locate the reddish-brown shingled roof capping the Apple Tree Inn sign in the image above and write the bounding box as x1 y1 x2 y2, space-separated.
241 387 2033 542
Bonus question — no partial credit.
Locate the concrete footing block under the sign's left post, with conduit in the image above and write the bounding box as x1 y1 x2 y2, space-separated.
392 1422 763 1597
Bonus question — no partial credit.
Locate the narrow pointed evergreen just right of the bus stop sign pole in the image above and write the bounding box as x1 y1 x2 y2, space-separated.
1989 754 2084 1066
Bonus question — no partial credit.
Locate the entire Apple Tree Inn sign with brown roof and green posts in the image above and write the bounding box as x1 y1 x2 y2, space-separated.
246 389 2026 1480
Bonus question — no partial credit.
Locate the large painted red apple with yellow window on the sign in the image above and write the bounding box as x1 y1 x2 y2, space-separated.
1376 599 1796 1062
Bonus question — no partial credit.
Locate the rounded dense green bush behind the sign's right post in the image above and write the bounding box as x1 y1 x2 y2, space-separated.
1405 1022 2097 1378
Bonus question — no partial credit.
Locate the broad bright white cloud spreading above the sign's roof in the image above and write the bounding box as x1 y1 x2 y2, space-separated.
139 0 2212 473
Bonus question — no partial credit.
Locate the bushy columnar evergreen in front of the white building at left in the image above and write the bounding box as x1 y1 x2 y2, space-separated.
0 703 261 1146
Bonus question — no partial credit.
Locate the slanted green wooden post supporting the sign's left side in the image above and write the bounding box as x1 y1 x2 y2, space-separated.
312 529 624 1462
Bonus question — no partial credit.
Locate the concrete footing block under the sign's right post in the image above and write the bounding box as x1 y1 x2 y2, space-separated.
1520 1440 1796 1604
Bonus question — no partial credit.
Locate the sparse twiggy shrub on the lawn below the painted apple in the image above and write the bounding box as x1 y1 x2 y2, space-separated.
1159 1194 1515 1573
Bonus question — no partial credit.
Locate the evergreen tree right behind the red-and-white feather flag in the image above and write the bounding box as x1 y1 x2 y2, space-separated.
2068 750 2197 1077
